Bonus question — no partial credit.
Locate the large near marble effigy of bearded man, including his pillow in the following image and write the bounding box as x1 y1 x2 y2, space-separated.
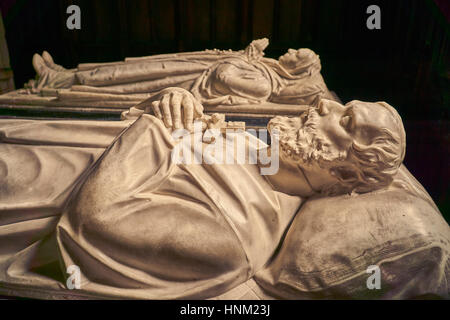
0 88 450 299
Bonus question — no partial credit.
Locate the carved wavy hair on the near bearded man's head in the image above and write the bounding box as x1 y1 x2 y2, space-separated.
322 102 406 195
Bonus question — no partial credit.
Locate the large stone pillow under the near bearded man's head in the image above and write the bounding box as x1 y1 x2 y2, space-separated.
255 166 450 299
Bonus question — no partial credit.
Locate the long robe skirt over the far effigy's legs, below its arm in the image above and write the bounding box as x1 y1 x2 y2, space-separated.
62 51 242 100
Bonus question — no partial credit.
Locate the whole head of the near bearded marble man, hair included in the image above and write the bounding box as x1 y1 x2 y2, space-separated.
268 99 406 195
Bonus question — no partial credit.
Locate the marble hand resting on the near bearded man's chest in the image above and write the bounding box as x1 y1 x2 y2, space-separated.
137 88 203 131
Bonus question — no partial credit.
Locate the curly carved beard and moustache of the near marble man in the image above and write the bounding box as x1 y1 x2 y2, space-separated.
268 107 347 168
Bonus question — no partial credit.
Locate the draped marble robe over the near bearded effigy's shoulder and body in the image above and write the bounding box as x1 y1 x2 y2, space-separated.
0 115 302 299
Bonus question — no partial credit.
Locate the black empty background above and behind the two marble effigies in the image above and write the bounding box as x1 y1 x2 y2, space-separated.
0 0 450 221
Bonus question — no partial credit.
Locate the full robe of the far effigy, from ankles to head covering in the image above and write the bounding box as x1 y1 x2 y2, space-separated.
54 51 334 106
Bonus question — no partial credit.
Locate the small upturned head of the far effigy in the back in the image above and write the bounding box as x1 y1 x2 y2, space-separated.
278 48 320 75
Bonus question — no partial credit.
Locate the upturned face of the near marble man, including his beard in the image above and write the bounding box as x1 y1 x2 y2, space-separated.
268 99 397 168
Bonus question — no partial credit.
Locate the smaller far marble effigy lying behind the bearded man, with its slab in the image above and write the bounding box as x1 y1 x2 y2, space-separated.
0 38 336 118
